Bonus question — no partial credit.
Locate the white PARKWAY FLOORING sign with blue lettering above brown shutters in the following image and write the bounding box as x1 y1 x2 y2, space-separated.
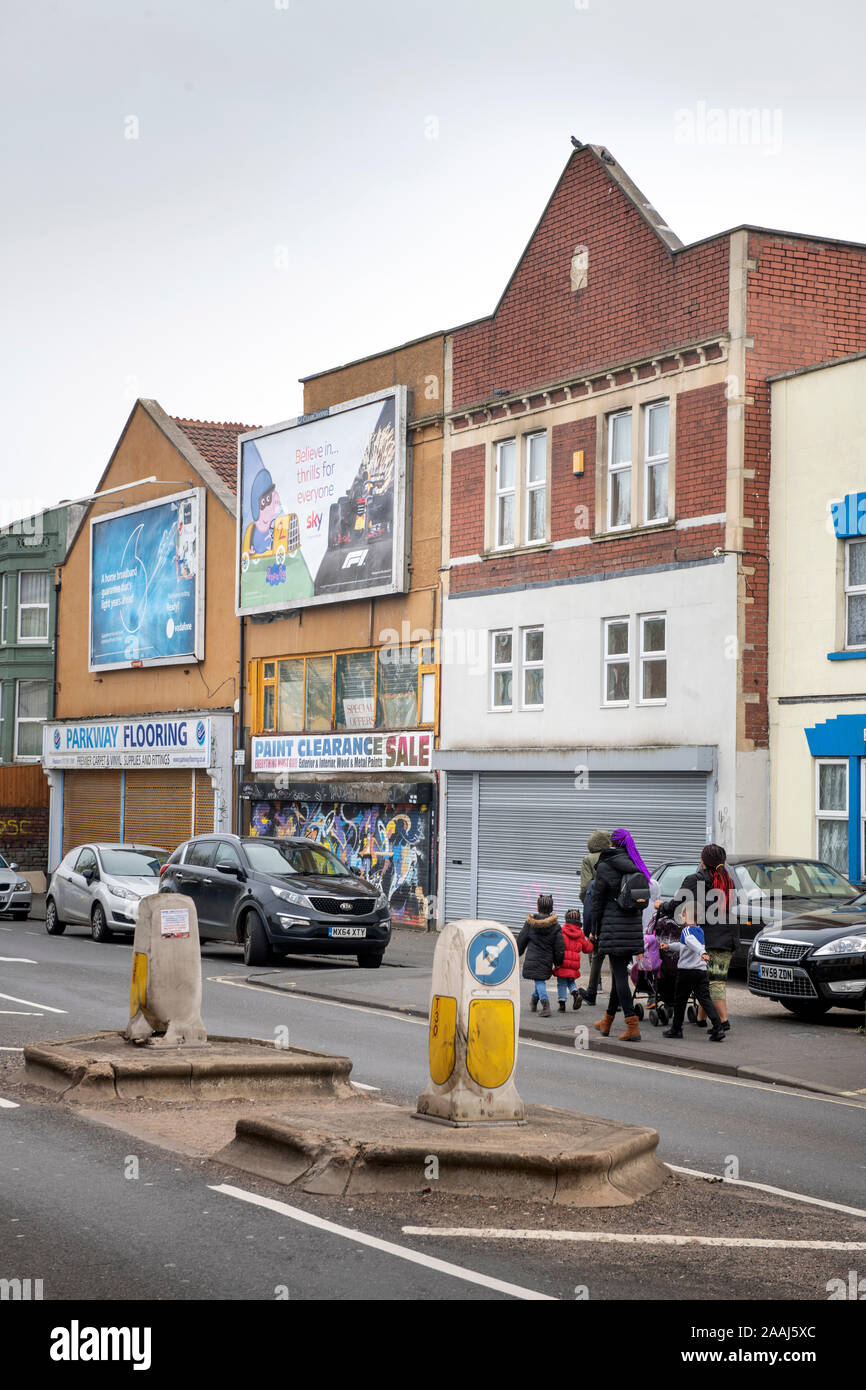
42 717 211 767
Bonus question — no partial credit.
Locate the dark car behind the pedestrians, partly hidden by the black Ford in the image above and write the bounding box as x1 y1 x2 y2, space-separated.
653 855 860 965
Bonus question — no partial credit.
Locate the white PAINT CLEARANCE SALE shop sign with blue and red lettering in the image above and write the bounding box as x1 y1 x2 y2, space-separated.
252 730 434 773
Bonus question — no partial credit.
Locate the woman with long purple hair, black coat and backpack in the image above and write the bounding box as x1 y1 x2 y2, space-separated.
592 830 649 1043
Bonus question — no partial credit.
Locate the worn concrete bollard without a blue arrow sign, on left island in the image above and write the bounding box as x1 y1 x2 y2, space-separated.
125 892 207 1047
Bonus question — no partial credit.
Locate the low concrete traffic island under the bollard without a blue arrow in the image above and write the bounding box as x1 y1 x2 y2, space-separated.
24 1031 357 1105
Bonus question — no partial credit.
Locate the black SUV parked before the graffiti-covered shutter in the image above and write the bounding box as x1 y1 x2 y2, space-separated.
160 834 391 970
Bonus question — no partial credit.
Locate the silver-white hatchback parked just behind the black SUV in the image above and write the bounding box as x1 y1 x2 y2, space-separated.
44 842 168 941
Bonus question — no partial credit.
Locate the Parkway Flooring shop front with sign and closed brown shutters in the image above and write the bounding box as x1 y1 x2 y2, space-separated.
43 712 232 870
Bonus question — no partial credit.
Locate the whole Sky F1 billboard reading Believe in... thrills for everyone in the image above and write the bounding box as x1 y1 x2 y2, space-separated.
236 386 409 614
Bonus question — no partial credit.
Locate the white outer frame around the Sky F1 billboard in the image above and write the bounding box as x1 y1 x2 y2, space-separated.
235 386 411 617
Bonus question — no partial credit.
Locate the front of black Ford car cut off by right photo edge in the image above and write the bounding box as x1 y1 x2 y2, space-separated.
748 892 866 1019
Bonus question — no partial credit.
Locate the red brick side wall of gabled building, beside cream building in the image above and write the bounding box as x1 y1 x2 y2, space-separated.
742 232 866 748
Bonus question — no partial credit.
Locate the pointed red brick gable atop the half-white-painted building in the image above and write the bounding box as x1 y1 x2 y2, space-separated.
453 147 728 407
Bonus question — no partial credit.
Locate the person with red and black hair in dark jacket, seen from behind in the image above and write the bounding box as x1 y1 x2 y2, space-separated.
656 845 740 1033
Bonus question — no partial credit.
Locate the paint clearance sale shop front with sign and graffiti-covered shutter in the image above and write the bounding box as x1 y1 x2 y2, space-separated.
243 730 436 927
